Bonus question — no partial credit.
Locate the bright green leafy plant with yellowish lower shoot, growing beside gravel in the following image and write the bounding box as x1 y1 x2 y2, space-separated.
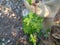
23 12 44 45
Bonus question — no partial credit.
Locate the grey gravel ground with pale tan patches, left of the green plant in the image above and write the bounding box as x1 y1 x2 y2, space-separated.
0 0 25 45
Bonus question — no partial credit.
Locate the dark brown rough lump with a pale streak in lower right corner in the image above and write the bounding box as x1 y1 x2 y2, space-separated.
50 25 60 45
